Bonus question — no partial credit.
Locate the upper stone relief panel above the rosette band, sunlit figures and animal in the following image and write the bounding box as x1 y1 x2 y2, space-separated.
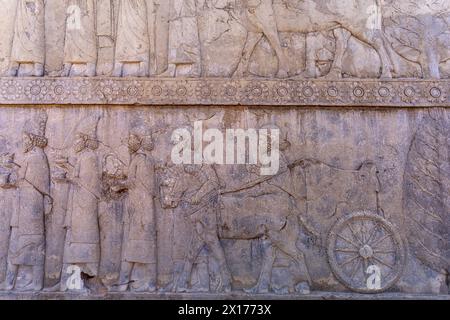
0 0 450 80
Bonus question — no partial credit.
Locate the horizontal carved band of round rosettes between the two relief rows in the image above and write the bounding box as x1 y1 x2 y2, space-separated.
0 77 450 107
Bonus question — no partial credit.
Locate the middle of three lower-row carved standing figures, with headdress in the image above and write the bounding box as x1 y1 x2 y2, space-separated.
61 117 101 291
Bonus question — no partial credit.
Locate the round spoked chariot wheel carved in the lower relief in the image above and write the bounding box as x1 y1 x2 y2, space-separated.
327 212 406 293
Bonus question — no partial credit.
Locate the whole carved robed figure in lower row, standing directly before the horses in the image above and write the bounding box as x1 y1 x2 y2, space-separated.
113 126 157 292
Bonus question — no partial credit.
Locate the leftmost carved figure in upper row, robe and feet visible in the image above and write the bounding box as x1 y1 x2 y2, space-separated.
9 0 45 77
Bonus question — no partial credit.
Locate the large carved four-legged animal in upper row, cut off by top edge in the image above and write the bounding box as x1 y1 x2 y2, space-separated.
234 0 398 79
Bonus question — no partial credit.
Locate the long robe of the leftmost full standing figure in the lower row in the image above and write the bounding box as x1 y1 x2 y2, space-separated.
9 148 50 266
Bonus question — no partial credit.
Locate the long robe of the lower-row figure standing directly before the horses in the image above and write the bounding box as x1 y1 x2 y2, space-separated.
123 153 156 263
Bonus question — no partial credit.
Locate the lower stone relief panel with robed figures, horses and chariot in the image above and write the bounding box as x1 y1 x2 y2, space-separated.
0 106 449 295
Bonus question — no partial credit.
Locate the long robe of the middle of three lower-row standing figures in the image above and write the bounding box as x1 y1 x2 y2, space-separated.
64 150 101 276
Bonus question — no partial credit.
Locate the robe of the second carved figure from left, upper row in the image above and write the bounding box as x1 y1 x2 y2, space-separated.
64 0 97 64
